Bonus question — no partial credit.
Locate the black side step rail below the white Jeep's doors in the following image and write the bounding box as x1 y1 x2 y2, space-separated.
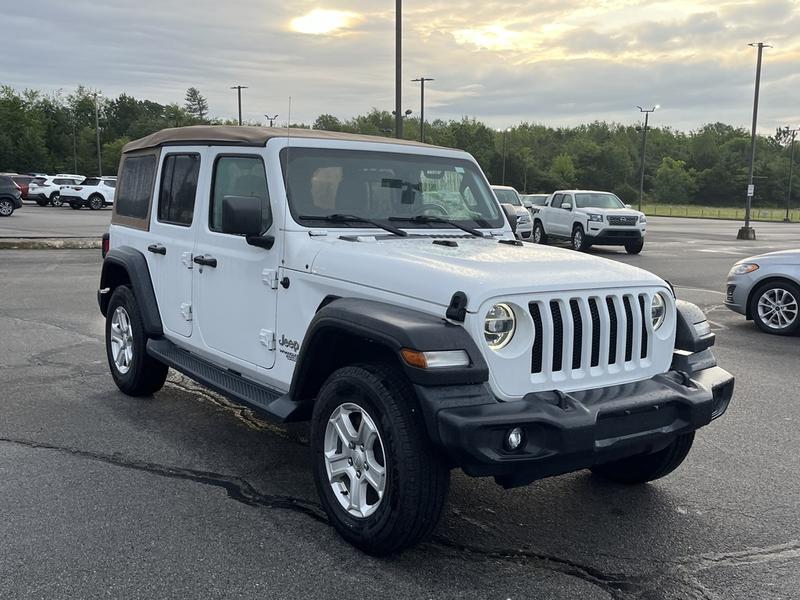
147 338 299 423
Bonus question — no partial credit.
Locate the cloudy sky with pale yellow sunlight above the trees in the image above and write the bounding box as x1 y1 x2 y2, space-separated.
0 0 800 132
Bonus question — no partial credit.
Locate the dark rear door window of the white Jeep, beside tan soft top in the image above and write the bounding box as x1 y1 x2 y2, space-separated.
158 154 200 227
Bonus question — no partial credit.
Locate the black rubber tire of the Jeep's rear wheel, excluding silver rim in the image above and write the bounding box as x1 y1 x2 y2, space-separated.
106 285 169 396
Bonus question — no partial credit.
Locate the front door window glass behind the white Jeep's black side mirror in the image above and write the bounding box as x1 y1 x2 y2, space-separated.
208 156 272 233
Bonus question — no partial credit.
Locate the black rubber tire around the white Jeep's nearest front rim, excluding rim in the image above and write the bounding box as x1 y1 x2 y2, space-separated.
311 363 450 556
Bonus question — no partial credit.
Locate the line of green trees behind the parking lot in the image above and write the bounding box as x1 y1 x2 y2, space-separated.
0 86 800 207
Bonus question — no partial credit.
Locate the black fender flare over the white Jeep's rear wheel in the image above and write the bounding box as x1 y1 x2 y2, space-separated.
97 246 164 338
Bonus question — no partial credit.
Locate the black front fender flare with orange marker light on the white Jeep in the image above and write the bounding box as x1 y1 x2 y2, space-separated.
289 298 489 402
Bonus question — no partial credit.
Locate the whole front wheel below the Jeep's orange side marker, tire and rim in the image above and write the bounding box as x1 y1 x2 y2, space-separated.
311 364 450 555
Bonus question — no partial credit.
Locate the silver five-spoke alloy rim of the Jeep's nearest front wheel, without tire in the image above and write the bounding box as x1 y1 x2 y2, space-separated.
324 402 387 519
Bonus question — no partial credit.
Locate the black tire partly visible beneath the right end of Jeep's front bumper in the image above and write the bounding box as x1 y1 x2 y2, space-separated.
591 431 694 484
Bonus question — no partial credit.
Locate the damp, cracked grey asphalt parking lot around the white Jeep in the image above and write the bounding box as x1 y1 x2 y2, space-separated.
0 218 800 600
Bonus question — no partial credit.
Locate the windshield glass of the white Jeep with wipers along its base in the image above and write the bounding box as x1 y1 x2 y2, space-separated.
281 147 505 229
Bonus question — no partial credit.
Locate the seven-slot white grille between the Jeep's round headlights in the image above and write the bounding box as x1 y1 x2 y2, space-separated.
528 292 652 379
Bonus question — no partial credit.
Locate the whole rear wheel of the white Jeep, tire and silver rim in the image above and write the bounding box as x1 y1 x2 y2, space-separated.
106 285 169 396
